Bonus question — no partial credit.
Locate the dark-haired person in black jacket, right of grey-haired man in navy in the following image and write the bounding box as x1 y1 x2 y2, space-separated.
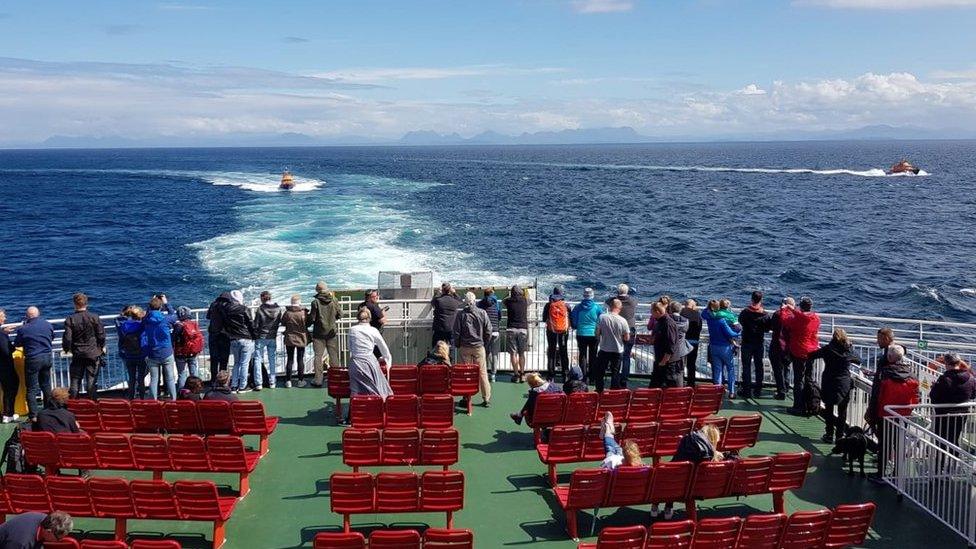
61 293 105 400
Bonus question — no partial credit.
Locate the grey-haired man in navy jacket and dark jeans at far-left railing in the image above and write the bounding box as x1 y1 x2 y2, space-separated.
14 306 54 420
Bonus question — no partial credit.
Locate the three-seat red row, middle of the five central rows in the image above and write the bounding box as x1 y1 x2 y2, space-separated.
342 427 460 471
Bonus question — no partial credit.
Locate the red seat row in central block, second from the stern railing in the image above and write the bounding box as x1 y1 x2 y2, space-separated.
349 394 454 429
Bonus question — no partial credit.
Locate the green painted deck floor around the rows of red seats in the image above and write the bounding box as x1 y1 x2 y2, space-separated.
3 382 965 549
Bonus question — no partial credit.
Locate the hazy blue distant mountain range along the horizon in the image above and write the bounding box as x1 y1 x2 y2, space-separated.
16 125 976 149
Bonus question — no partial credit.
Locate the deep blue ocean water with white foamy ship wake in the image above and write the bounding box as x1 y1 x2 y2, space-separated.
0 141 976 322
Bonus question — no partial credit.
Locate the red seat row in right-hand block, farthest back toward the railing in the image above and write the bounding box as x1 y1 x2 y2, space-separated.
529 384 725 440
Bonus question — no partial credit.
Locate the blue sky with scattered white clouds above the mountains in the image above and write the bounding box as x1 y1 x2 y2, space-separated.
0 0 976 146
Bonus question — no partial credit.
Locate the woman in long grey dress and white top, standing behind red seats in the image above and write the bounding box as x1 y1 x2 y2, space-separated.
349 307 393 400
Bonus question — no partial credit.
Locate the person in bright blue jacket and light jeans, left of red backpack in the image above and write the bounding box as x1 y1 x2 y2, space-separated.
142 294 178 400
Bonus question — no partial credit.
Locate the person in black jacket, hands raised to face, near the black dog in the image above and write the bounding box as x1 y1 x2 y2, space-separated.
807 328 861 443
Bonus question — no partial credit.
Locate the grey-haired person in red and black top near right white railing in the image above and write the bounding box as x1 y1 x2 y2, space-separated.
869 345 919 482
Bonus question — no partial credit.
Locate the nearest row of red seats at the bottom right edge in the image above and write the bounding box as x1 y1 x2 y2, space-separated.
579 503 875 549
